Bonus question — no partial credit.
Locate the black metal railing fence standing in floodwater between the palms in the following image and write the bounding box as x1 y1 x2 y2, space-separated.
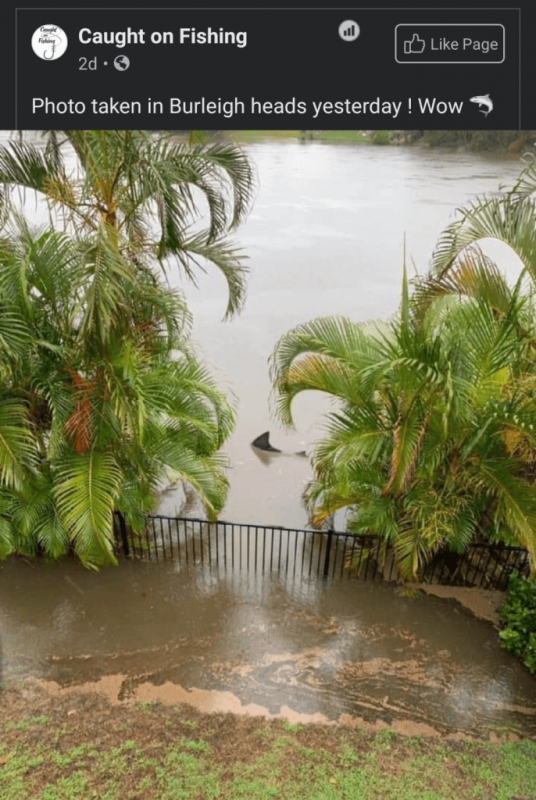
114 514 529 589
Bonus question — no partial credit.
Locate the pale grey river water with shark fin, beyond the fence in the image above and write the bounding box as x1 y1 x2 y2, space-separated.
175 142 520 527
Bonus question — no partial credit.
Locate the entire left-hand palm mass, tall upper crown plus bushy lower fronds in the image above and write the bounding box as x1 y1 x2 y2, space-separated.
0 131 252 568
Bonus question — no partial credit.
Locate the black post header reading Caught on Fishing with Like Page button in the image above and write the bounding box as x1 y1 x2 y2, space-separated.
14 8 524 130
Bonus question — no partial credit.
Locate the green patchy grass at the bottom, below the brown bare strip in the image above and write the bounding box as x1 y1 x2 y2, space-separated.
0 709 536 800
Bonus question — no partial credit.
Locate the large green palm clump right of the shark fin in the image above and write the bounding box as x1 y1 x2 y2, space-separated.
272 272 536 579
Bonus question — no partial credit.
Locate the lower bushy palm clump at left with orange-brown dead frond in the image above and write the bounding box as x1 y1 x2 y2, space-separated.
0 221 234 567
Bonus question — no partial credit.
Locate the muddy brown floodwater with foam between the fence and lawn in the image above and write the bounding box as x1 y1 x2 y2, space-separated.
0 560 536 736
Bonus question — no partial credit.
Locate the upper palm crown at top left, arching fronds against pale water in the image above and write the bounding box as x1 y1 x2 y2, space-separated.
0 131 254 318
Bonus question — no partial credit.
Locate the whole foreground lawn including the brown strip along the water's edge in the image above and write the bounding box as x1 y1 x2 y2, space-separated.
0 686 536 800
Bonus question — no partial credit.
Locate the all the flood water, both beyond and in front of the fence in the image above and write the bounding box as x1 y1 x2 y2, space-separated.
0 142 536 736
